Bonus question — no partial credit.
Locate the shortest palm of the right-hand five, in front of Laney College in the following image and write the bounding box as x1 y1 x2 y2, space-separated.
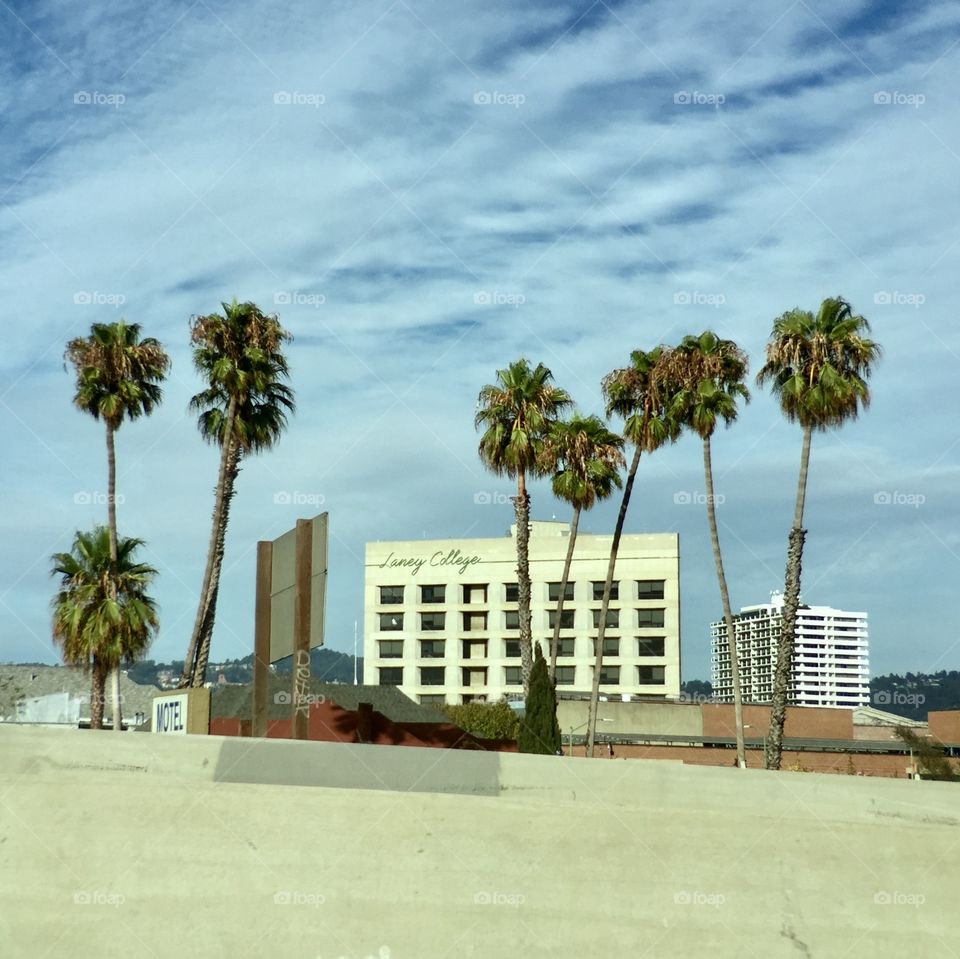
543 413 626 682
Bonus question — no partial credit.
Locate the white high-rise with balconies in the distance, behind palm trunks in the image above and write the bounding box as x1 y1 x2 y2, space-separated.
710 593 870 709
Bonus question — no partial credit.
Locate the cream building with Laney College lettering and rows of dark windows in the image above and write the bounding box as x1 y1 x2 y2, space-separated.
363 522 680 703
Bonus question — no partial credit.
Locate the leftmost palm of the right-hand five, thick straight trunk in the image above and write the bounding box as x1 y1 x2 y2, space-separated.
475 358 571 698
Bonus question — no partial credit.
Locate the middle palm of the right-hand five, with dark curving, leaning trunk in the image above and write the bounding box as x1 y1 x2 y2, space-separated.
587 345 680 757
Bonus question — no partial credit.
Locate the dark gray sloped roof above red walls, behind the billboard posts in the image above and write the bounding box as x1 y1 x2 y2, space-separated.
210 673 450 723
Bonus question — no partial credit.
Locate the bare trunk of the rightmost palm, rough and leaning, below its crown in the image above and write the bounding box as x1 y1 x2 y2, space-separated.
764 426 813 769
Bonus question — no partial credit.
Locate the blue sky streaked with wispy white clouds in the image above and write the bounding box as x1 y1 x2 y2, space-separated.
0 0 960 678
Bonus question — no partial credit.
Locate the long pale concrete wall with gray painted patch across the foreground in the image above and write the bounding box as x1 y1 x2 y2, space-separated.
0 727 960 959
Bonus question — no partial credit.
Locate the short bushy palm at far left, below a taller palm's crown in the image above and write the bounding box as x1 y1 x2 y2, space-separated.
52 526 158 729
